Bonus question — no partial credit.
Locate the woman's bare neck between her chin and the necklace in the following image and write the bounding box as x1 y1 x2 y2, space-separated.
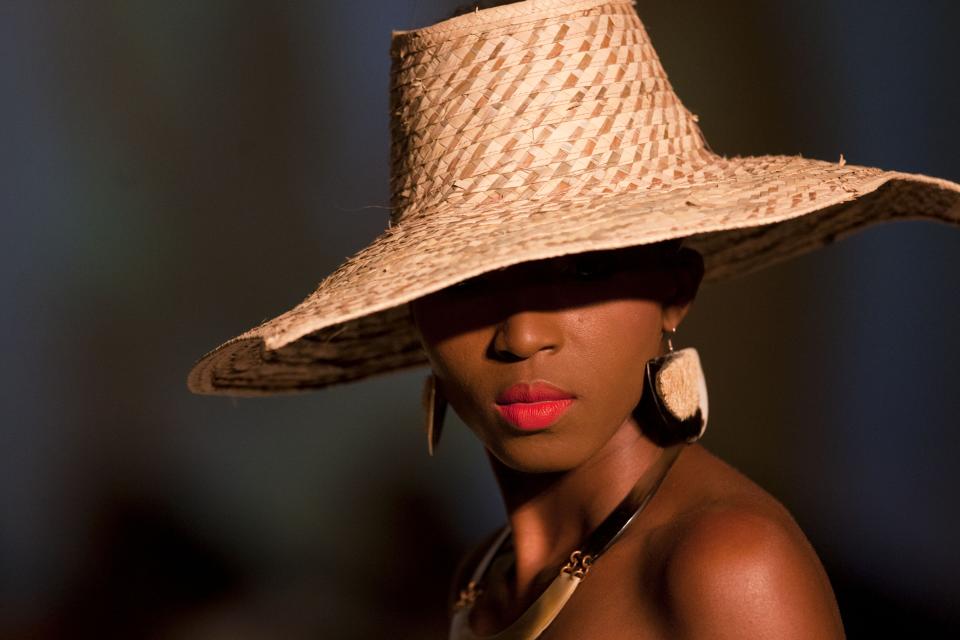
490 419 662 599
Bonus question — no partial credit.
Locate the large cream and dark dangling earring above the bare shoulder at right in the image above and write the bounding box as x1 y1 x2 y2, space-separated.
636 329 709 446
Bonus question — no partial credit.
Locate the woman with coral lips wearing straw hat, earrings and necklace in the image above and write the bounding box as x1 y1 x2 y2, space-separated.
188 0 960 638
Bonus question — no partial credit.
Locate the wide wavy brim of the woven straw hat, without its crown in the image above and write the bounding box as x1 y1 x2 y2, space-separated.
187 156 960 396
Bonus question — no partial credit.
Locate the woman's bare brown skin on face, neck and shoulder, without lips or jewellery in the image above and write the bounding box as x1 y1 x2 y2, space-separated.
411 245 844 640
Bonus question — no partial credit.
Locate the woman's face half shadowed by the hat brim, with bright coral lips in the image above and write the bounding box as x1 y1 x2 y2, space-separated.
412 245 703 472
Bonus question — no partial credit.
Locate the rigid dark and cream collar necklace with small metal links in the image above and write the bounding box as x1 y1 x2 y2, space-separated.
450 443 685 640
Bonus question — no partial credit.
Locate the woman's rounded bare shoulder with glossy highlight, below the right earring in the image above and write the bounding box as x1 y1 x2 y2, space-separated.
662 450 844 640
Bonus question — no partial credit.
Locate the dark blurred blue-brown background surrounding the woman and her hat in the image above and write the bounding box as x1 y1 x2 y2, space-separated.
0 0 960 639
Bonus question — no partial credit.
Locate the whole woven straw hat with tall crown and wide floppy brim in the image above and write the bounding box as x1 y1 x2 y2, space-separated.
187 0 960 395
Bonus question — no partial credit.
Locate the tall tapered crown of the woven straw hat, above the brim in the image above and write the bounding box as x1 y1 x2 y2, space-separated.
391 0 709 222
